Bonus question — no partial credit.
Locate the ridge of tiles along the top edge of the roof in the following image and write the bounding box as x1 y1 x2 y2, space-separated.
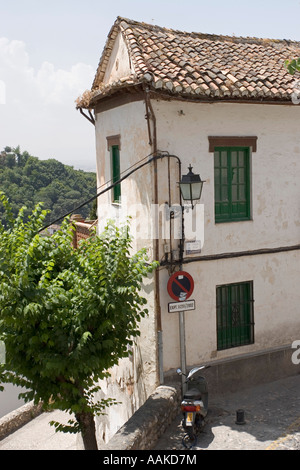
115 16 300 47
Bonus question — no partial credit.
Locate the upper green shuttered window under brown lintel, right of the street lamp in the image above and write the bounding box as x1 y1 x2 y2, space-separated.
214 147 250 222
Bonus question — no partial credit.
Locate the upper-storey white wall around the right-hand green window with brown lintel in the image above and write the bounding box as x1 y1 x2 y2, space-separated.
154 101 300 255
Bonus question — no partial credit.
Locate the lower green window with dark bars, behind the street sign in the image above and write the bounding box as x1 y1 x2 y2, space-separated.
216 281 254 350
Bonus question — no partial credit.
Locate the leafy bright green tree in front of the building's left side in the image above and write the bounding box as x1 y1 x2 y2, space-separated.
0 193 157 449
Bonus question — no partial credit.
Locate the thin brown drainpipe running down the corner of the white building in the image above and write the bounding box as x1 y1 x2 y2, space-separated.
145 87 164 384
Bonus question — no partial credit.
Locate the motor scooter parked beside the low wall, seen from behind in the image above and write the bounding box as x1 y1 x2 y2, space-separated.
177 366 210 448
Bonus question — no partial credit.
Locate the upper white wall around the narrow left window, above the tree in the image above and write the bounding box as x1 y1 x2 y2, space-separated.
96 101 157 256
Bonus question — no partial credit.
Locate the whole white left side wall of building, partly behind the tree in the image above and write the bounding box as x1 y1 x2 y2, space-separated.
96 102 158 441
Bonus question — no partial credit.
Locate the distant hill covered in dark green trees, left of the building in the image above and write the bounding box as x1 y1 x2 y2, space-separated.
0 147 96 223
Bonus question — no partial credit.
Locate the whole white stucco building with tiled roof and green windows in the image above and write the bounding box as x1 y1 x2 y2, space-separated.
78 18 300 442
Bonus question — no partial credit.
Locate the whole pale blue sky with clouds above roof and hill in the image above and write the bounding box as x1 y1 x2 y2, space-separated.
0 0 300 170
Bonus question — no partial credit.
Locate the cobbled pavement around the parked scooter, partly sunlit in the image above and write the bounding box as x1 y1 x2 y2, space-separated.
155 375 300 450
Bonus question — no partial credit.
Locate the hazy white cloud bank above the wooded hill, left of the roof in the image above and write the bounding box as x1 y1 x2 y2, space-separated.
0 38 95 169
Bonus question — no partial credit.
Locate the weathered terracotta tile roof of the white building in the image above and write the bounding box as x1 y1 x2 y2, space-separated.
80 18 300 106
